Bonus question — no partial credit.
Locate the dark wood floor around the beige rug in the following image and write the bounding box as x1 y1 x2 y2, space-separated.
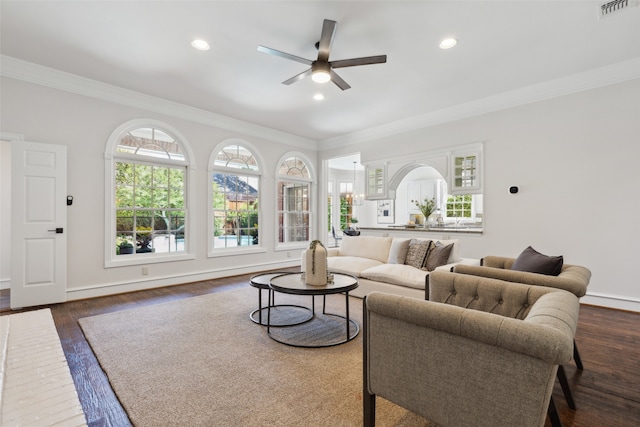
0 275 640 427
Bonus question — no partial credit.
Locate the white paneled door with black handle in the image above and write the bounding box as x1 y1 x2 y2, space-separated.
10 142 67 309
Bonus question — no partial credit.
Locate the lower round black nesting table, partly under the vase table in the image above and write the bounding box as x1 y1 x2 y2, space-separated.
249 272 313 327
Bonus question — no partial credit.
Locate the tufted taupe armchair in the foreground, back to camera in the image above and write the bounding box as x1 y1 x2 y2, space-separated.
363 271 579 426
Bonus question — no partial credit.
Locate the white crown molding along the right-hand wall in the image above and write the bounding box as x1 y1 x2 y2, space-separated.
319 58 640 151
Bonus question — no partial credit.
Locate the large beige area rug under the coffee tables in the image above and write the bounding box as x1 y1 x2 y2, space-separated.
79 287 436 427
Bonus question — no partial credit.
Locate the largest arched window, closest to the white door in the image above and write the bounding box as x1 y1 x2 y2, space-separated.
105 120 193 266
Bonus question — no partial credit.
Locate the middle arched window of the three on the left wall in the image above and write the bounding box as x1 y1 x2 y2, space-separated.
209 139 261 254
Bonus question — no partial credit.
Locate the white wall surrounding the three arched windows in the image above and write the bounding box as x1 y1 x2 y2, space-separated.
0 78 317 299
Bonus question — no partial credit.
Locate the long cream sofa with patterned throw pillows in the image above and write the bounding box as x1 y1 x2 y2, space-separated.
302 236 480 299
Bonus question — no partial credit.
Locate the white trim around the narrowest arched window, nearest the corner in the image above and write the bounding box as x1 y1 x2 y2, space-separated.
273 151 320 252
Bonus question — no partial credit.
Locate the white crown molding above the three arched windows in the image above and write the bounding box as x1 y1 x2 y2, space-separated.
0 55 318 150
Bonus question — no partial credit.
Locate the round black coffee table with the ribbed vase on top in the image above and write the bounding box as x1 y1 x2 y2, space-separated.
267 273 360 348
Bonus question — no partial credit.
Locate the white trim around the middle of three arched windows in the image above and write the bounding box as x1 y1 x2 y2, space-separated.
207 138 267 258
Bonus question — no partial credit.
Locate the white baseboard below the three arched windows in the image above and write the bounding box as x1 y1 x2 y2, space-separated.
67 260 300 301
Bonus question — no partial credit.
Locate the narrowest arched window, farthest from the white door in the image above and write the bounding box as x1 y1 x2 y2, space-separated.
277 155 312 246
